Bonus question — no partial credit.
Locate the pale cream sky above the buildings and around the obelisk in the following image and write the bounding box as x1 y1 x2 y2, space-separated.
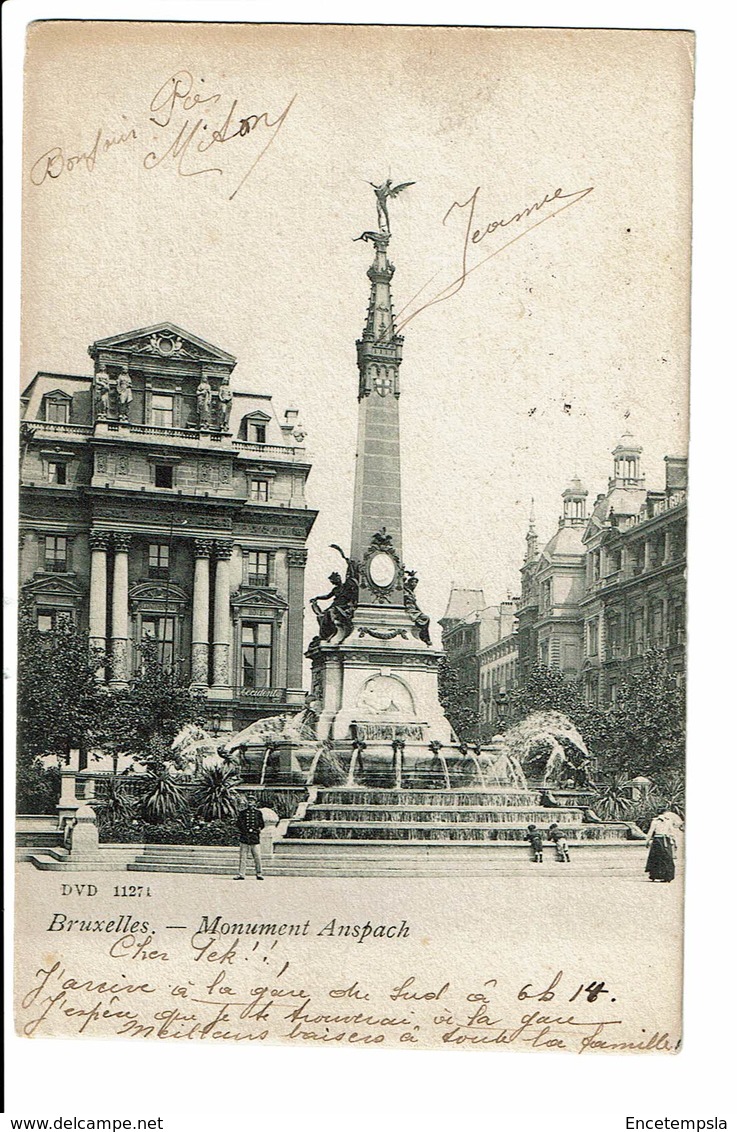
20 24 692 636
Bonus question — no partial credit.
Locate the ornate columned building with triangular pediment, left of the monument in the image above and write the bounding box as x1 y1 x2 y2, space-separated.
20 323 316 729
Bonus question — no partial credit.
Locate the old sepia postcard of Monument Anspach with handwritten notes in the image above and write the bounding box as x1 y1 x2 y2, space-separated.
15 20 694 1055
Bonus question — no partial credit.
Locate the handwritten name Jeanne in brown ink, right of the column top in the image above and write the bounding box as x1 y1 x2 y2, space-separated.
395 185 593 333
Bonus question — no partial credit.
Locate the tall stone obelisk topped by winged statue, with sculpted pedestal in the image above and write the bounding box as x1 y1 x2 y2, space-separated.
307 180 453 744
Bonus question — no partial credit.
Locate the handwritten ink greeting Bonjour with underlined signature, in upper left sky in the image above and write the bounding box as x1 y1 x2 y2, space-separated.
29 70 297 200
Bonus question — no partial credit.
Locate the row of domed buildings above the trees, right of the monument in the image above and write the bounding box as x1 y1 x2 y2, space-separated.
440 434 687 715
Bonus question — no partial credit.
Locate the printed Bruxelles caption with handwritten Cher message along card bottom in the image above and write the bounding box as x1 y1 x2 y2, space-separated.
17 912 679 1054
